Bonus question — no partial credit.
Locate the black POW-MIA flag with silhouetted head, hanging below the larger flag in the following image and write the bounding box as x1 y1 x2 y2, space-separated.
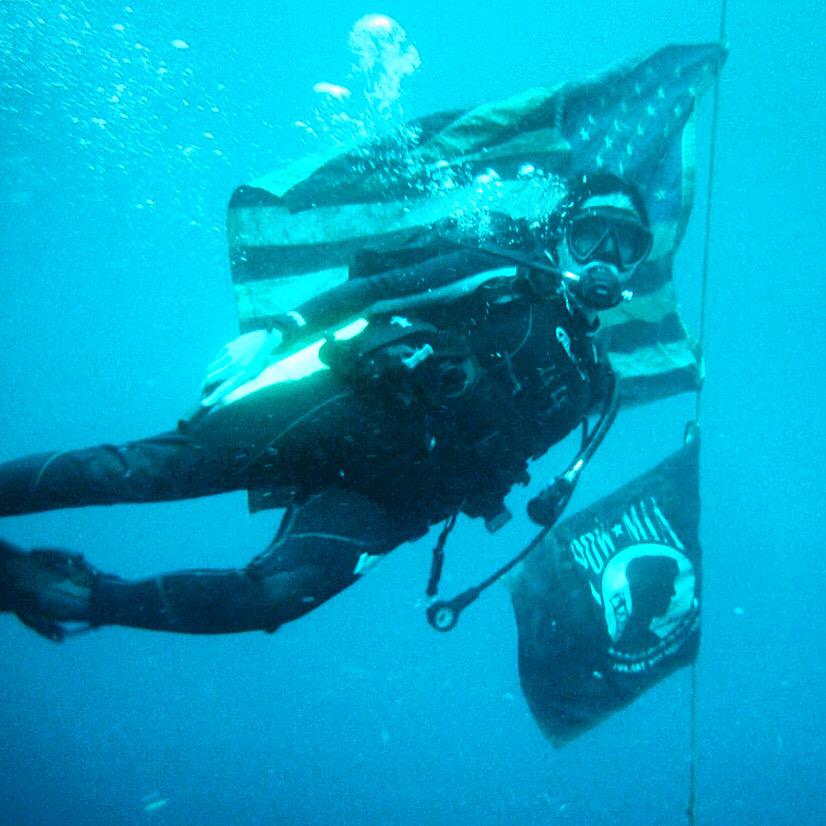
507 438 701 747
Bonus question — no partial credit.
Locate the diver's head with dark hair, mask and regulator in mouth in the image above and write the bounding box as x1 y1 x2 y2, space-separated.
551 174 652 310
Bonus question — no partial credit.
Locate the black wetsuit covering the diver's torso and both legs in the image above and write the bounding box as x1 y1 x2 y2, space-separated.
0 253 608 633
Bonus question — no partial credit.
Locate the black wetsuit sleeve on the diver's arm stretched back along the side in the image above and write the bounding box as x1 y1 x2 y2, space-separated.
275 249 503 338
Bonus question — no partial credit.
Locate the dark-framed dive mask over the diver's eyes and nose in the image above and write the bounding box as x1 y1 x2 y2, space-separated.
565 207 653 270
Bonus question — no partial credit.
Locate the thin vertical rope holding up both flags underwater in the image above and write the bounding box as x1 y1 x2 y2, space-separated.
686 6 728 826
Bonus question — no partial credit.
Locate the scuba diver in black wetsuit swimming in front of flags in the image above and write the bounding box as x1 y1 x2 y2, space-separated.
0 174 652 641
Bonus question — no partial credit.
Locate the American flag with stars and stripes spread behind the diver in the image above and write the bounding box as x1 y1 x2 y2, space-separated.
228 44 725 403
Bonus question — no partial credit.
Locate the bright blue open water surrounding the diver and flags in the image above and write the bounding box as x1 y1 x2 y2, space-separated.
0 0 826 826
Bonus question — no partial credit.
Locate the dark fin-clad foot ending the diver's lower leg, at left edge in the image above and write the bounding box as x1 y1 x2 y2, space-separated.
0 540 99 642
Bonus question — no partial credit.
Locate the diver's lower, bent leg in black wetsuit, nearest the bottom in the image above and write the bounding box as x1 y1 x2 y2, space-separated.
0 489 426 634
